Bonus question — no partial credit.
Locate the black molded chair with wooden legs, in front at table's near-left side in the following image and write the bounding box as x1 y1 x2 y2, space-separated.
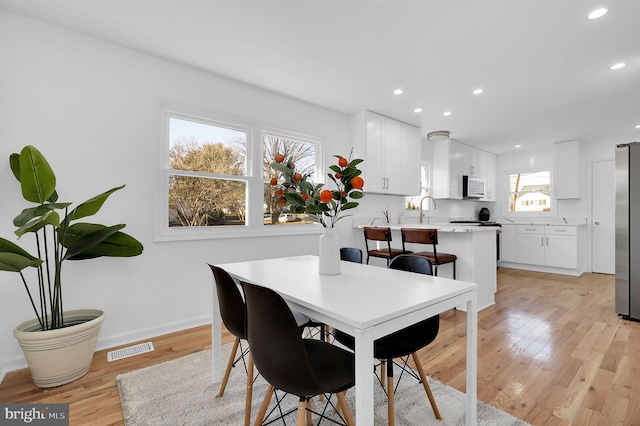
242 282 355 425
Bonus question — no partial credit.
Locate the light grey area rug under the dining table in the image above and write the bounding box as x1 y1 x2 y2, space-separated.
117 345 528 426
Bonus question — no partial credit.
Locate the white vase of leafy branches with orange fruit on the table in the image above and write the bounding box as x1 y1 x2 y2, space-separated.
270 154 364 275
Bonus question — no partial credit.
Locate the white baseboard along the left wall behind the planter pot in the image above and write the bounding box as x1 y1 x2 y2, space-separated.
0 315 211 383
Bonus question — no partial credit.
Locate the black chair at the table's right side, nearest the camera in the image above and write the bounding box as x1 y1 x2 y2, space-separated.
333 254 442 425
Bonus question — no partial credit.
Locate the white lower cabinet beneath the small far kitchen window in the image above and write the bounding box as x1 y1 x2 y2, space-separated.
515 225 578 269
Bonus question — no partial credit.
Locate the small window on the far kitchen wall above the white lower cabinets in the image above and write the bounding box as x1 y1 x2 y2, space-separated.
508 170 551 213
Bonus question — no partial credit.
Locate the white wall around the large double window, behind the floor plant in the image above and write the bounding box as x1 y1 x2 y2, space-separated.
0 12 350 377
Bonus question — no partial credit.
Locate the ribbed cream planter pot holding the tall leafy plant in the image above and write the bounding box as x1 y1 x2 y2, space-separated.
13 309 105 388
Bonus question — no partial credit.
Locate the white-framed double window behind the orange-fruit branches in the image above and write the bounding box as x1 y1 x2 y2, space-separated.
156 107 324 240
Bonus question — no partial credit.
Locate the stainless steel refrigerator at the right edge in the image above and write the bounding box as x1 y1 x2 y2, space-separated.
616 142 640 320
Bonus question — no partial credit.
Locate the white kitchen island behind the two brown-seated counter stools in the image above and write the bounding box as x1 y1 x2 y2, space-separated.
353 223 499 310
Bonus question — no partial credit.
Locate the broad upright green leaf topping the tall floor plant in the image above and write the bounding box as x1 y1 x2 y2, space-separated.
18 145 56 204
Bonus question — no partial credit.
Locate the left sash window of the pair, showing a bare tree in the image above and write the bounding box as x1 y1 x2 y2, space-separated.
168 117 249 227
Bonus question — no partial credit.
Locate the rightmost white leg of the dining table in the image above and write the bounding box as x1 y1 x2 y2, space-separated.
465 290 478 426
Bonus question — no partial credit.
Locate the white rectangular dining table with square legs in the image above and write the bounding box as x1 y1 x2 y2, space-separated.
212 255 478 426
